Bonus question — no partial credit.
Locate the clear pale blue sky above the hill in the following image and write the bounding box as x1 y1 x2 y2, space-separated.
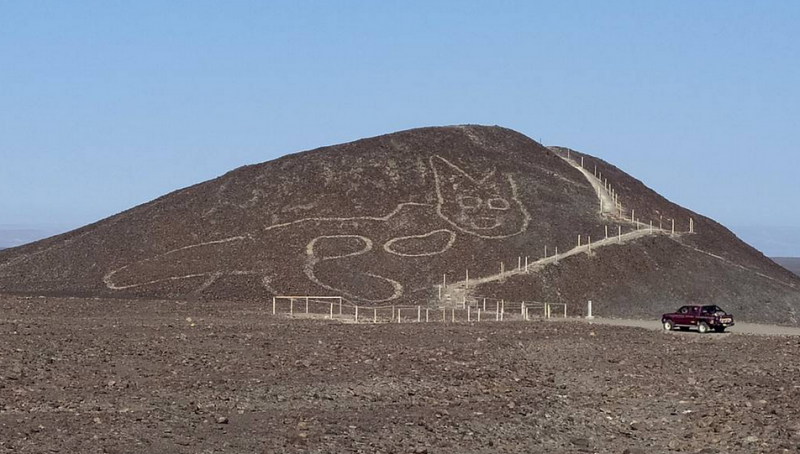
0 0 800 256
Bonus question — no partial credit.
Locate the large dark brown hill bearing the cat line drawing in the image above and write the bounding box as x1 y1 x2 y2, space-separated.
0 126 800 323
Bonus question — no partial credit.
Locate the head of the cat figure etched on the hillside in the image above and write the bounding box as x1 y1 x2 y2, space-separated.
431 156 530 238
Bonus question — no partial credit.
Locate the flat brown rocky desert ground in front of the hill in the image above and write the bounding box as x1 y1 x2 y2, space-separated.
0 296 800 453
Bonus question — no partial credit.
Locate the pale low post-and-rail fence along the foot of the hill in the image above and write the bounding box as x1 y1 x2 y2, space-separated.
272 295 567 323
